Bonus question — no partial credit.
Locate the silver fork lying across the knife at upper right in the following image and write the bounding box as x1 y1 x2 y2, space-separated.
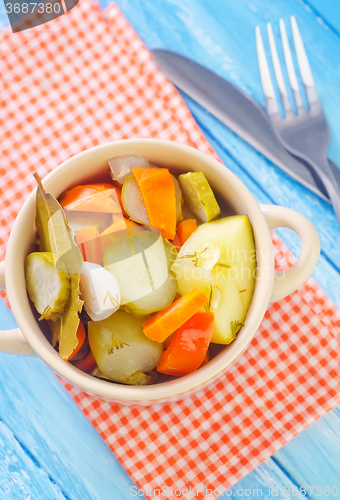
256 16 340 225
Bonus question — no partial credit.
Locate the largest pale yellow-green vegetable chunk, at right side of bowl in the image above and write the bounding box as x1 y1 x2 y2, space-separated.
172 215 256 344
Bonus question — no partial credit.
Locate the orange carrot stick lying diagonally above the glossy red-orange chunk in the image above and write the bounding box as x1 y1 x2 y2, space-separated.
143 288 208 342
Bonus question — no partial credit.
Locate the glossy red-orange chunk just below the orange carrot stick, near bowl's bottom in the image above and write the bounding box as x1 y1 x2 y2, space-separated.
157 312 214 377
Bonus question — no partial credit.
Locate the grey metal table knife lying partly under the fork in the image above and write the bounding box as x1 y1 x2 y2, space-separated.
151 49 340 201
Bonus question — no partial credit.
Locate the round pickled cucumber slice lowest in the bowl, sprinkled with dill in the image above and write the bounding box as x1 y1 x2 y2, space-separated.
88 311 163 385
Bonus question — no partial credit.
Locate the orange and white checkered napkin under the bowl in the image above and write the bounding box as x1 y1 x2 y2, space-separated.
0 0 340 498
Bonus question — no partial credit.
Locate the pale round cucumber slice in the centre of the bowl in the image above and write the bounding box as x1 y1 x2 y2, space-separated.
103 231 177 315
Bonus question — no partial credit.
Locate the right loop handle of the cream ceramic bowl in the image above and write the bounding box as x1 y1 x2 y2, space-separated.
260 205 320 302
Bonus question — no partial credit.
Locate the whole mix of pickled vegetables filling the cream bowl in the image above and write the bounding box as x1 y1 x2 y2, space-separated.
25 155 256 385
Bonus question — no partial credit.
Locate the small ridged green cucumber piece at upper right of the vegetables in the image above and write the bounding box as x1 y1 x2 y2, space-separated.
178 172 221 222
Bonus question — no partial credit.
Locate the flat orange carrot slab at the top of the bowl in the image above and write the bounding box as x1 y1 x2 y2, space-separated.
132 168 176 240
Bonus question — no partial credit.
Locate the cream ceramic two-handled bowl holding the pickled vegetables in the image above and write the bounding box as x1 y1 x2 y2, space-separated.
0 139 320 404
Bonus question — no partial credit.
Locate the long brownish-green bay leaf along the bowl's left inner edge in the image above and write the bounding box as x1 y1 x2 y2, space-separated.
34 173 83 359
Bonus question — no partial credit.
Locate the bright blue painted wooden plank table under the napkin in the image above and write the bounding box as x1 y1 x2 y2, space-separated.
0 0 340 500
